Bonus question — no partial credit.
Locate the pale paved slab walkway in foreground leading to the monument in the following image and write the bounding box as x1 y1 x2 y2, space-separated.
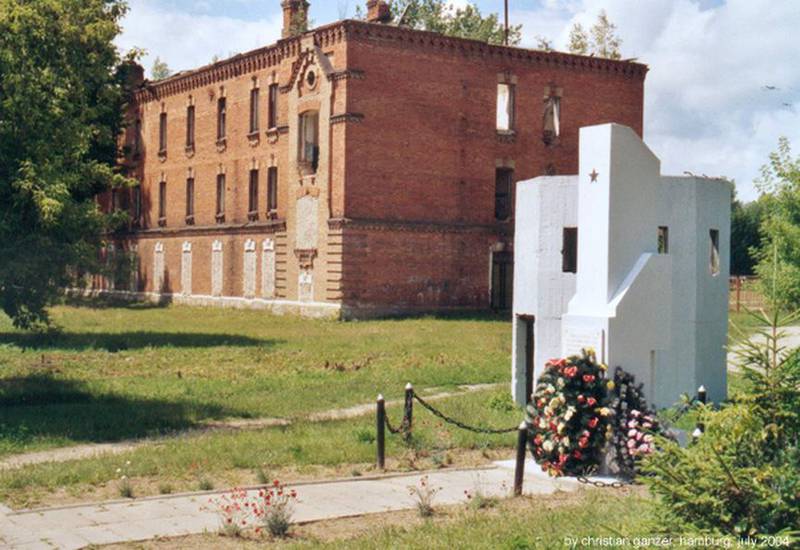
0 461 580 550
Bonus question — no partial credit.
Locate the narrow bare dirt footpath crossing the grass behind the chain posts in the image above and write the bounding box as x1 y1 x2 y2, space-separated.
0 384 503 471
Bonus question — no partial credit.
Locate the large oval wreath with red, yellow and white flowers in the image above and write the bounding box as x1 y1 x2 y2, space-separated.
526 349 612 476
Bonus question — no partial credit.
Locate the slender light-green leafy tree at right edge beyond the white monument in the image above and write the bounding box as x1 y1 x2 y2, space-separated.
756 137 800 309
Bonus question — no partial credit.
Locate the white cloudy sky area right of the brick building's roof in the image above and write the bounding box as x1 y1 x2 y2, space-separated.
514 0 800 203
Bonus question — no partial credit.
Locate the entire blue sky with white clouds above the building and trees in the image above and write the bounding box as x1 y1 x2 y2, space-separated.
118 0 800 200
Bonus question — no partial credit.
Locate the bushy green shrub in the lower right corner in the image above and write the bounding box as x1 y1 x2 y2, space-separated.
644 405 800 537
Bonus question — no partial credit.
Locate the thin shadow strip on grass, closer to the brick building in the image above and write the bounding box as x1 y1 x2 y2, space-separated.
0 331 280 353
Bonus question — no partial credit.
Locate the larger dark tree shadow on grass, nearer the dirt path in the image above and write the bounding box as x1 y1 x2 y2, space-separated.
0 374 245 452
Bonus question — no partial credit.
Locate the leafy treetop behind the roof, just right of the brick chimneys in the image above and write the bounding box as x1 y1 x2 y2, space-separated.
391 0 522 45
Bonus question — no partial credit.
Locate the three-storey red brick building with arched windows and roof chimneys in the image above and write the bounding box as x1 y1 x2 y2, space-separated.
110 0 647 317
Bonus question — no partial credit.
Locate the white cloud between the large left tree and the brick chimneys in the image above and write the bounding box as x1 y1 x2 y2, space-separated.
117 0 282 78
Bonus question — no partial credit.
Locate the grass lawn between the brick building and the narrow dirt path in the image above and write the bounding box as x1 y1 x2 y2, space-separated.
0 306 511 457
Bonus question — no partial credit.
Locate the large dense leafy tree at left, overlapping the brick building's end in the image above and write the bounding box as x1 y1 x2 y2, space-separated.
0 0 132 328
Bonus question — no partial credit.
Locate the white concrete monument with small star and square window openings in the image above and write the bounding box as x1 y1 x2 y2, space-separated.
512 124 732 407
